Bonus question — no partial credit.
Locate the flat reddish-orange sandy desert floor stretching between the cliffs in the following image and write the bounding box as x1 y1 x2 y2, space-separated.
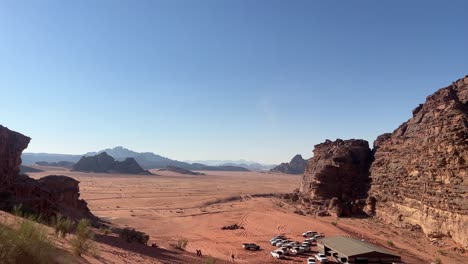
29 167 468 264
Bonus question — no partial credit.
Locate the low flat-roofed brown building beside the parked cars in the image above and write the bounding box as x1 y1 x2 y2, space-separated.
317 236 401 264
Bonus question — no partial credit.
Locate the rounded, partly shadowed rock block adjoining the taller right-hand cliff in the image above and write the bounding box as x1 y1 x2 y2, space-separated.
299 139 372 216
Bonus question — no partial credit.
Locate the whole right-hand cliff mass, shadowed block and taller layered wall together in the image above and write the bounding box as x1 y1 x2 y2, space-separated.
300 76 468 248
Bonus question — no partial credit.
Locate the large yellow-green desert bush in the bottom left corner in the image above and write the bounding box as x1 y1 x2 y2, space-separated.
0 219 55 264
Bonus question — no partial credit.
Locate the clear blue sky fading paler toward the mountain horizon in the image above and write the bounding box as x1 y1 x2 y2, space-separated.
0 0 468 163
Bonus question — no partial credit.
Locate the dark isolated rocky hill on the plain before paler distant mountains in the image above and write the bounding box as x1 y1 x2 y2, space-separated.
73 152 151 174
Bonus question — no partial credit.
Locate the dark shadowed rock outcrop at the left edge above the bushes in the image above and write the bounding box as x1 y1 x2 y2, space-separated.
0 126 96 220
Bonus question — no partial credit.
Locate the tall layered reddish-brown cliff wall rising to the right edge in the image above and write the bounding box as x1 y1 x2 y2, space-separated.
367 77 468 247
